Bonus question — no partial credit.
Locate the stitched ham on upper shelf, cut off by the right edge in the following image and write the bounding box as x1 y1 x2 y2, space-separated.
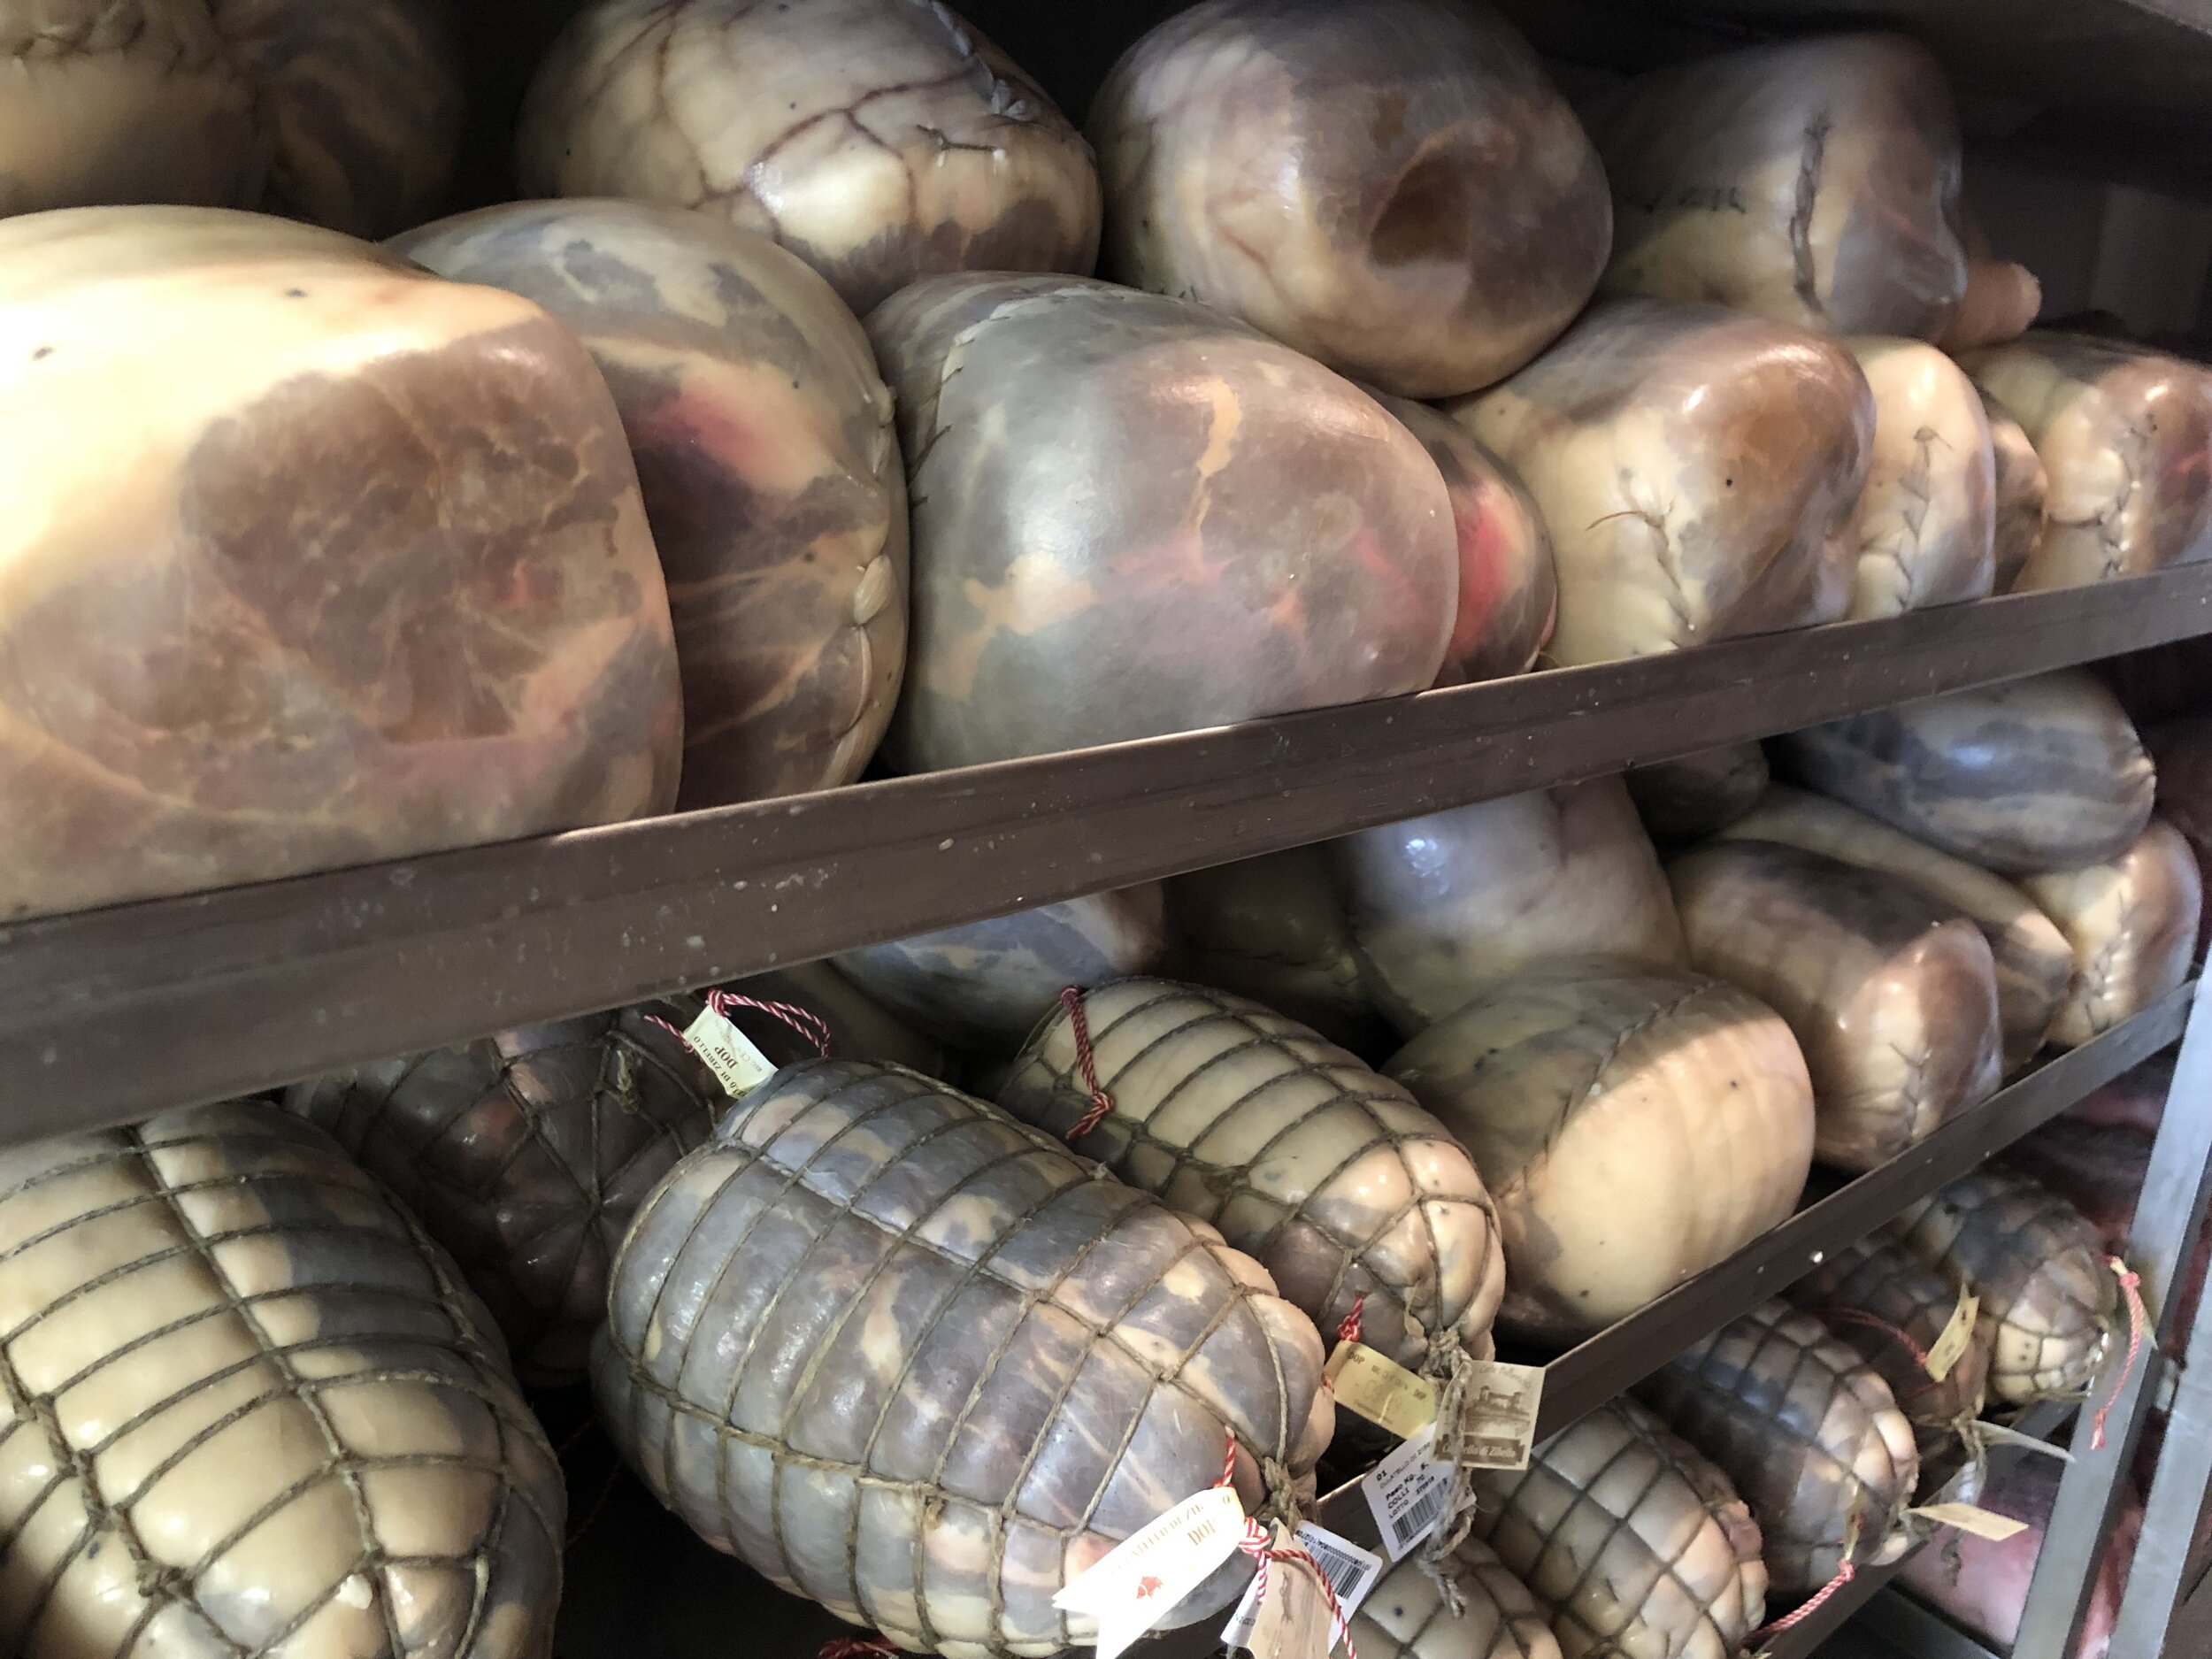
1964 330 2212 593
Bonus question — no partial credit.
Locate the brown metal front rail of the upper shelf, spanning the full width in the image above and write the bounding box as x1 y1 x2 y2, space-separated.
0 565 2212 1144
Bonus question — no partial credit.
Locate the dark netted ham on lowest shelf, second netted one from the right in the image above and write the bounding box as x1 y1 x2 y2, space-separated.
1786 1239 1991 1491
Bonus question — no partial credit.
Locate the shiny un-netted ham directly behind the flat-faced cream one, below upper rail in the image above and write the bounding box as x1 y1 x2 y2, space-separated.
1330 779 1684 1038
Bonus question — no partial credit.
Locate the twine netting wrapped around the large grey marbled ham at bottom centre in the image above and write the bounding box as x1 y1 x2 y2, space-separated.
611 1062 1301 1655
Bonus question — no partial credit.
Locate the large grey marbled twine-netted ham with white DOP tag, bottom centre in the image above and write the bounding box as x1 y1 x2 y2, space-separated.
593 1062 1332 1659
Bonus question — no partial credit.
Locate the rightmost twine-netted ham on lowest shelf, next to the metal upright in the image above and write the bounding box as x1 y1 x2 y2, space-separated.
1889 1171 2119 1405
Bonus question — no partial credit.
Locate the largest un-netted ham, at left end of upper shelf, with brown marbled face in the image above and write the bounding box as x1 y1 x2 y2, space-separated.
0 208 681 916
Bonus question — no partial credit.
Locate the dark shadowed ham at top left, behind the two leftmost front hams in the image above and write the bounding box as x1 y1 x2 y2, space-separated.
211 0 463 237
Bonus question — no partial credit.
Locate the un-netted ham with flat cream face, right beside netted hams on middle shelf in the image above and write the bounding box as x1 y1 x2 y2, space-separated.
1385 960 1814 1345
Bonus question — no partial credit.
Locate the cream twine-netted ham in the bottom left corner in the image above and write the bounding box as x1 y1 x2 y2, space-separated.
0 1102 565 1659
